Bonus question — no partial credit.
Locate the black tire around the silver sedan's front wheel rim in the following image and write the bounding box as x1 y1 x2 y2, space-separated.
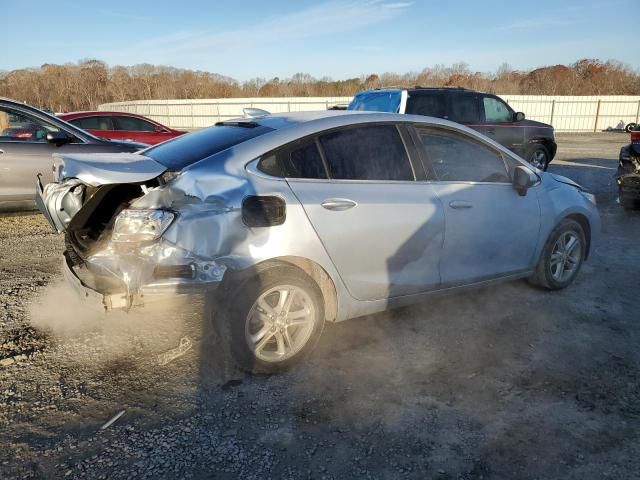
529 219 587 290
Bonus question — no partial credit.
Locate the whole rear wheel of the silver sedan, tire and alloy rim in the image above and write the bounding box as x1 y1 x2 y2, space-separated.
222 266 324 373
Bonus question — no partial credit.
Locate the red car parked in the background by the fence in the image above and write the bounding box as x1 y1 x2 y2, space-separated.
58 112 186 145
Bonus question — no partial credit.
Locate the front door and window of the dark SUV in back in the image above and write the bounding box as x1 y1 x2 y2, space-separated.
473 95 525 153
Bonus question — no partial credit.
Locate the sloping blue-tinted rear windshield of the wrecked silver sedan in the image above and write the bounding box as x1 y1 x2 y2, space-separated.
144 125 273 171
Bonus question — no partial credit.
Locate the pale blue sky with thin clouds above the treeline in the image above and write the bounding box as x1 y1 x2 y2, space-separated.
0 0 640 81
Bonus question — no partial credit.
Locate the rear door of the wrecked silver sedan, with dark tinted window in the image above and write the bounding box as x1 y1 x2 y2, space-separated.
285 124 444 300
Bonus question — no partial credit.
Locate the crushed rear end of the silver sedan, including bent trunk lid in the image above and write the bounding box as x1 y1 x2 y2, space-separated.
36 154 224 310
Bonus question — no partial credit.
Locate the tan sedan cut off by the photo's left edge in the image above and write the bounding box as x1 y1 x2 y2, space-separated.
0 98 146 211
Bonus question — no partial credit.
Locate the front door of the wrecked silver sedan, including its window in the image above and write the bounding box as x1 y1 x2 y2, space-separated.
415 127 540 285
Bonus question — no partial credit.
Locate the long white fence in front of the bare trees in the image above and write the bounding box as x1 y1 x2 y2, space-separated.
98 95 640 132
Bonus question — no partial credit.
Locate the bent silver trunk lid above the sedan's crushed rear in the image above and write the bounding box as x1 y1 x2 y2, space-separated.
53 153 167 187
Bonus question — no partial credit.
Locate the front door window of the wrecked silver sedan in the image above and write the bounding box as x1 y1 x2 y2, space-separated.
418 129 511 183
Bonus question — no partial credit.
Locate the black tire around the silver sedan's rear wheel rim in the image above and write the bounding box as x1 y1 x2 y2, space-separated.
215 265 325 374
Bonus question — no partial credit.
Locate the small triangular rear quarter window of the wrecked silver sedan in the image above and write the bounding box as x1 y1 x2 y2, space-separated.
258 140 327 179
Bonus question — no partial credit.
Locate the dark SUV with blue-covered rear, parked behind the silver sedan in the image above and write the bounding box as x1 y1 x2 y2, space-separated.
348 87 557 170
